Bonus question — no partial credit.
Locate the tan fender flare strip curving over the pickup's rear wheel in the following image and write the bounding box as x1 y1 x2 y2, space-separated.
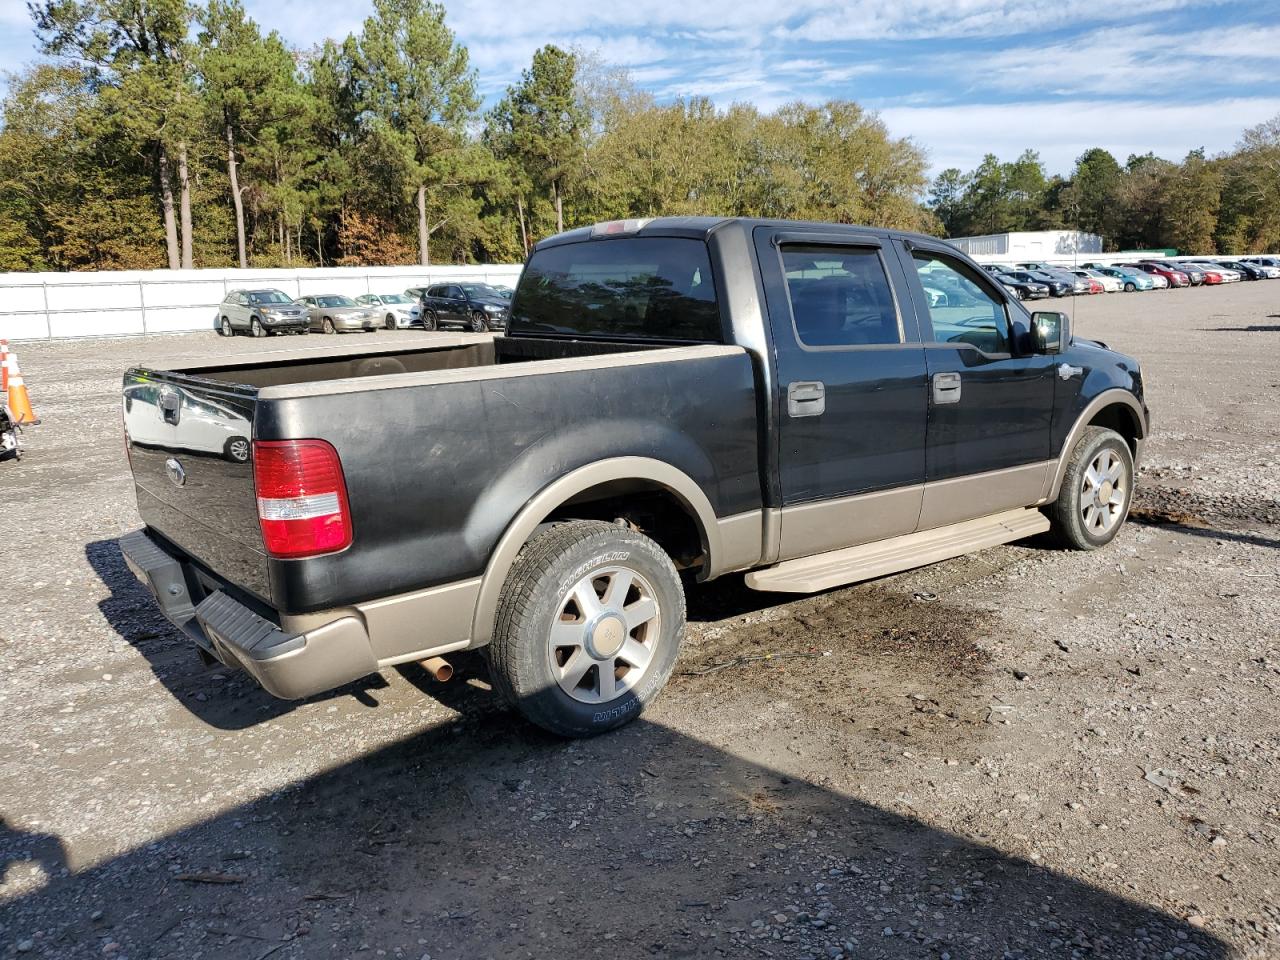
471 457 723 646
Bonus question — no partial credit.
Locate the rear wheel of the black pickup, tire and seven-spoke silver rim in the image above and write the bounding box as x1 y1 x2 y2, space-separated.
486 520 685 737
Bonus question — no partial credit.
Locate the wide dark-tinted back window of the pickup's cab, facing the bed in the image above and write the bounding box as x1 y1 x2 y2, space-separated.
508 237 723 343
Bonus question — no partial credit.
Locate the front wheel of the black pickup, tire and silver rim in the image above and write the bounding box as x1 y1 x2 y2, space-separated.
1047 426 1134 550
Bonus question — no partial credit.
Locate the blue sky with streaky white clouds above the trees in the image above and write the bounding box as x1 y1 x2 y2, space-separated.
0 0 1280 173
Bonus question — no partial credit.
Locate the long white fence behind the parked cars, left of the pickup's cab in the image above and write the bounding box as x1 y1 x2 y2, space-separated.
0 264 521 340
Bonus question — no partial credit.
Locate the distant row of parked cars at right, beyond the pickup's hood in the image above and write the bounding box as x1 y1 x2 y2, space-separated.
984 256 1280 300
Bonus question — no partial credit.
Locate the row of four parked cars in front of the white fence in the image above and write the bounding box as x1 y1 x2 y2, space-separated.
218 282 512 337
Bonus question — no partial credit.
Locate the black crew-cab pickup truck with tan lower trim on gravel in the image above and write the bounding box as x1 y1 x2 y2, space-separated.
120 218 1148 736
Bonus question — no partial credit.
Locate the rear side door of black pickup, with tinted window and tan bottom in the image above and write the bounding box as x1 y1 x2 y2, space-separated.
755 227 927 559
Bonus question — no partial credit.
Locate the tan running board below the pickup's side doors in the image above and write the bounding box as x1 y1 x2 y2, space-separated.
746 509 1048 594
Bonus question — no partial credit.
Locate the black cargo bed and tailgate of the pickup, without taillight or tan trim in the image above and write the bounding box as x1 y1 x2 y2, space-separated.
124 335 760 616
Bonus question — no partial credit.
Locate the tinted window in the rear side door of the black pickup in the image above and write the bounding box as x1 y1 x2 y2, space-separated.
782 246 902 347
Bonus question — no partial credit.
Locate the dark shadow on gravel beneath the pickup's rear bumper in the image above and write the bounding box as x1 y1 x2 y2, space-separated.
84 540 387 730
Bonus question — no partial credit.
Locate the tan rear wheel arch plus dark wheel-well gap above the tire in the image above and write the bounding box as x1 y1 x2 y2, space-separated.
471 457 722 646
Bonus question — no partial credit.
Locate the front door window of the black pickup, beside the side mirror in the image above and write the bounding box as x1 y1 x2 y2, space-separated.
914 251 1010 355
